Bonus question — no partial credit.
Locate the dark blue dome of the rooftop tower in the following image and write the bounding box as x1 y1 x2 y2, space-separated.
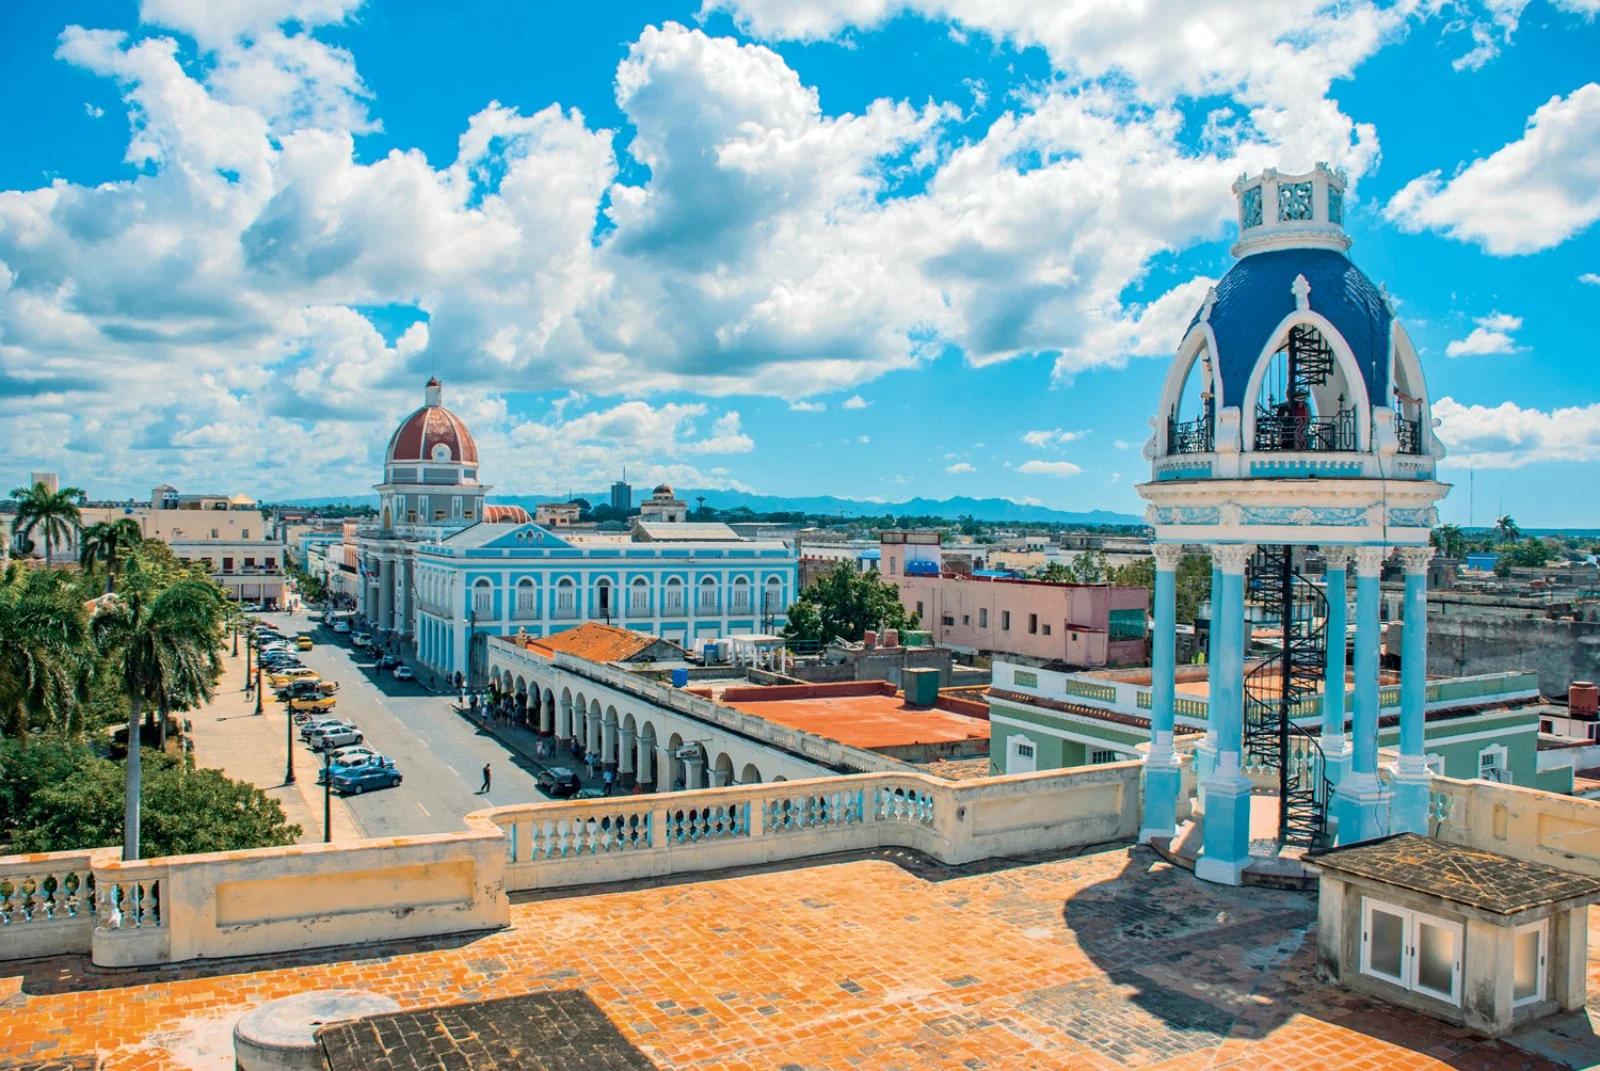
1186 248 1394 407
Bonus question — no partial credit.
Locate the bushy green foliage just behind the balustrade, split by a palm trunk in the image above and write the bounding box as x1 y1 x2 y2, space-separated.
0 746 301 856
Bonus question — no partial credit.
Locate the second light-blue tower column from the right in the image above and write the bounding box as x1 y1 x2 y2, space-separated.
1333 546 1389 844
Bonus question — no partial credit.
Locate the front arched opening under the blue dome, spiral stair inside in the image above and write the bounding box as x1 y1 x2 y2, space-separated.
1251 323 1360 453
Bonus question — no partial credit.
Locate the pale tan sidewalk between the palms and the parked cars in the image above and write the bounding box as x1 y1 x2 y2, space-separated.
186 645 366 844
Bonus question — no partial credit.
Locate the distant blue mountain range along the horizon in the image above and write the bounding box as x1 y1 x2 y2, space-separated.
285 487 1144 525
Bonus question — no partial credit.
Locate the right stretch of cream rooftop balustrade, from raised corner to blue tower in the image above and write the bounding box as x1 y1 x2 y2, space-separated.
474 762 1139 892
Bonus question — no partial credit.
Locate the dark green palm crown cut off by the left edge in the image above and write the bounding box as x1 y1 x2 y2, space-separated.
0 562 88 740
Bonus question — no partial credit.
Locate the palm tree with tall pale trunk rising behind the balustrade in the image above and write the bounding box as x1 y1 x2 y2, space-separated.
96 559 224 860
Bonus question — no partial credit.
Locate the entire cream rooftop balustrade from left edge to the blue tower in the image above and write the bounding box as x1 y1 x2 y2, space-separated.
0 762 1141 967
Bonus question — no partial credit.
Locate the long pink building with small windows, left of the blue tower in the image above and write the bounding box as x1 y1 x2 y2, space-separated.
883 541 1150 668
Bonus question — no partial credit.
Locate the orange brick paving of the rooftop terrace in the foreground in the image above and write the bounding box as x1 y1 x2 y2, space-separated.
0 848 1600 1071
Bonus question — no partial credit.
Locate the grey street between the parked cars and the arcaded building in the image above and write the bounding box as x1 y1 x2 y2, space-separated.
252 613 546 837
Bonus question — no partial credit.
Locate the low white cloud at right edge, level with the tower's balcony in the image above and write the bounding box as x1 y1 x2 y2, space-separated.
1434 397 1600 469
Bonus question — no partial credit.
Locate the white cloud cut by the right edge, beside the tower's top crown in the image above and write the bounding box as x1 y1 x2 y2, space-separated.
1384 82 1600 256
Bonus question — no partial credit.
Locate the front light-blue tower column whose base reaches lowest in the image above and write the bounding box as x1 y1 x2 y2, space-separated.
1195 543 1256 885
